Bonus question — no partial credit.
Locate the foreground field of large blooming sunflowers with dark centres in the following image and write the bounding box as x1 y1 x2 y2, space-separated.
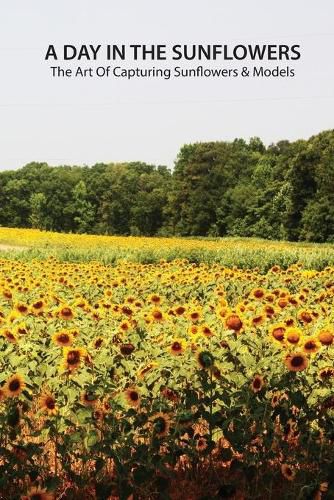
0 233 334 500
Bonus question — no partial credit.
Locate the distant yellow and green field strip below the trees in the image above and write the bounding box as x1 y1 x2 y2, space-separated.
0 228 334 271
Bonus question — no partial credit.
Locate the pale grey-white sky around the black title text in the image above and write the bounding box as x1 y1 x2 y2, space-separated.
0 0 334 170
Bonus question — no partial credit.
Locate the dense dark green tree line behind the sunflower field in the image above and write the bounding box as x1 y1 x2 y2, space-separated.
0 130 334 242
